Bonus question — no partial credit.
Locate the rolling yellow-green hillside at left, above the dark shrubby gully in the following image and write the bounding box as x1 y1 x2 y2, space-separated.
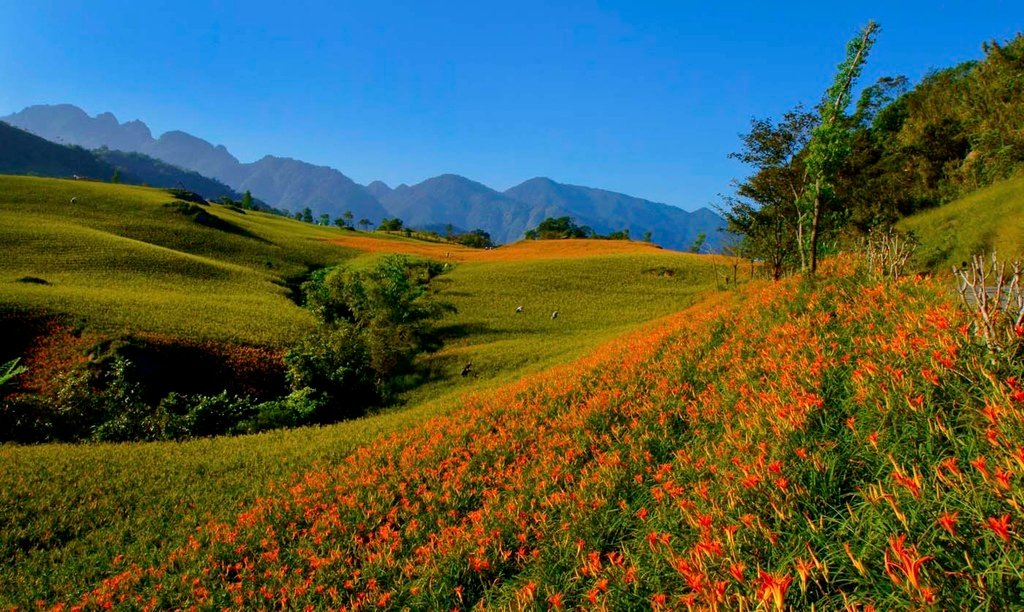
0 177 352 346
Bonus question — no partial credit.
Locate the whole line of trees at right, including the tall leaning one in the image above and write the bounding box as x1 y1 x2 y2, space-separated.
719 26 1024 278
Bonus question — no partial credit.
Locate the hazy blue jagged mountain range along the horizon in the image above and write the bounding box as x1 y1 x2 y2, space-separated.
0 104 724 250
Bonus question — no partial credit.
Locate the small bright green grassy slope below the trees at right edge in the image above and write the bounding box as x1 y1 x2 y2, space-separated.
896 177 1024 271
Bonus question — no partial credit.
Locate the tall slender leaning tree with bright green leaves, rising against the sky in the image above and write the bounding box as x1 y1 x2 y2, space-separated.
800 21 879 274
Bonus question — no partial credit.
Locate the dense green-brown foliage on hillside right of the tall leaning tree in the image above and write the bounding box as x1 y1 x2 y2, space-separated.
837 35 1024 232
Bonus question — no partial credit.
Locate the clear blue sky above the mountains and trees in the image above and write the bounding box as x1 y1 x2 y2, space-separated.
0 0 1024 209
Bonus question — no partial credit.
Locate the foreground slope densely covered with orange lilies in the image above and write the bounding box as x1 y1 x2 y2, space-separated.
58 260 1024 610
